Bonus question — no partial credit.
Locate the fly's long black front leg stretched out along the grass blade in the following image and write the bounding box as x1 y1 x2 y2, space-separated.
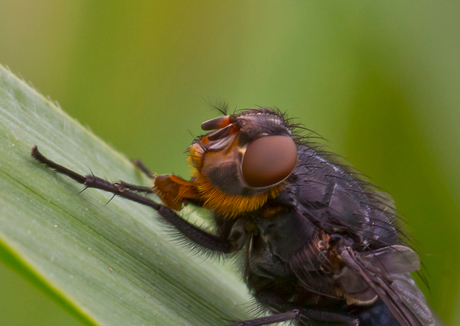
31 146 238 253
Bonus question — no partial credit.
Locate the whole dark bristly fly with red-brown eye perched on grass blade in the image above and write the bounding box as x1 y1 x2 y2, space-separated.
32 108 441 326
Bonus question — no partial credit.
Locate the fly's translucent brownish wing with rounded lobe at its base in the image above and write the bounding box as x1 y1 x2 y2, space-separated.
337 245 441 326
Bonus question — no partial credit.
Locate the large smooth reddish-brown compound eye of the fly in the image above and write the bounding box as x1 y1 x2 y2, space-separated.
243 136 297 188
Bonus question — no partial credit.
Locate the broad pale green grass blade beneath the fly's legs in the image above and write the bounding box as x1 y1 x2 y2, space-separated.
0 66 253 325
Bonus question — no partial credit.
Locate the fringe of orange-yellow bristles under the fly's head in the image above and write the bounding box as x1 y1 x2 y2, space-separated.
193 169 283 218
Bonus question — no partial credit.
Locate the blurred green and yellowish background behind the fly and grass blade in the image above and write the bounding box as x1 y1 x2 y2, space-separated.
0 0 460 326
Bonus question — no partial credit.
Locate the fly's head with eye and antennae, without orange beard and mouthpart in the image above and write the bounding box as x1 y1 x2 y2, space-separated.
190 108 297 196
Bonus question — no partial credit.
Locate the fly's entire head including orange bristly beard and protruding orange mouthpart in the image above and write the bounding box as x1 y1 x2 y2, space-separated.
155 109 297 217
